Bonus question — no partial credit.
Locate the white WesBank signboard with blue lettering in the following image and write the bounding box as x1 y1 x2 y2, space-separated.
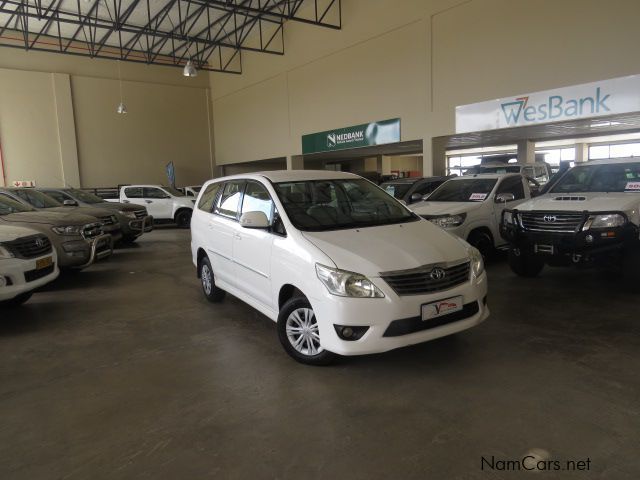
456 75 640 133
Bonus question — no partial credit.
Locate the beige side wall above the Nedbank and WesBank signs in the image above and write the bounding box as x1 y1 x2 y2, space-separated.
210 0 640 173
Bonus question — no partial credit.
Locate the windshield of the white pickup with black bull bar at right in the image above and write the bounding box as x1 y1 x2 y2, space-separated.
551 162 640 193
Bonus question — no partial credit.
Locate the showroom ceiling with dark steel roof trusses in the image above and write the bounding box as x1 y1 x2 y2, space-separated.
0 0 341 73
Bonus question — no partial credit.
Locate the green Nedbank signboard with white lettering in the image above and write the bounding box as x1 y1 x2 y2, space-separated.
302 118 400 155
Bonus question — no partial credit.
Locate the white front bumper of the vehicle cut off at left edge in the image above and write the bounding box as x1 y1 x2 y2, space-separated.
0 252 60 301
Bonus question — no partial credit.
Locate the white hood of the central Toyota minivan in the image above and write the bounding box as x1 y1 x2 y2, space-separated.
302 220 468 277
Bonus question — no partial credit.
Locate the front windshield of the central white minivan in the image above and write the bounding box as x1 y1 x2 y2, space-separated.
275 179 418 231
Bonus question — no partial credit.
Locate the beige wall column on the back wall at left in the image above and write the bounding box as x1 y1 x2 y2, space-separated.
51 73 80 188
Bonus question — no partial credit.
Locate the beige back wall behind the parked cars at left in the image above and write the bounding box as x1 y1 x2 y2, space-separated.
0 48 216 187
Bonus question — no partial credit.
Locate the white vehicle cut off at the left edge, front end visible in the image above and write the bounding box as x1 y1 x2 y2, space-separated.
0 225 59 306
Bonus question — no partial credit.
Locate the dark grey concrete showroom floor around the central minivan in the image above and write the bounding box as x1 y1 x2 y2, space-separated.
0 229 640 480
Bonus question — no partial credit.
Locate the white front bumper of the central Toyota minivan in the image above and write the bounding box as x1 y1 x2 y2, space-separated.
310 272 489 355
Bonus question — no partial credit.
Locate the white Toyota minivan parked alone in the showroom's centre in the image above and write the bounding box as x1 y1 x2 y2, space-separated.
191 170 489 365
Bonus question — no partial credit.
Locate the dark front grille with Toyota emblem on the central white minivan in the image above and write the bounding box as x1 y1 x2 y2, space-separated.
380 262 470 295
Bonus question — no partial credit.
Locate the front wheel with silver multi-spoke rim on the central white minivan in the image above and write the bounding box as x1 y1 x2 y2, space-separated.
278 297 335 365
